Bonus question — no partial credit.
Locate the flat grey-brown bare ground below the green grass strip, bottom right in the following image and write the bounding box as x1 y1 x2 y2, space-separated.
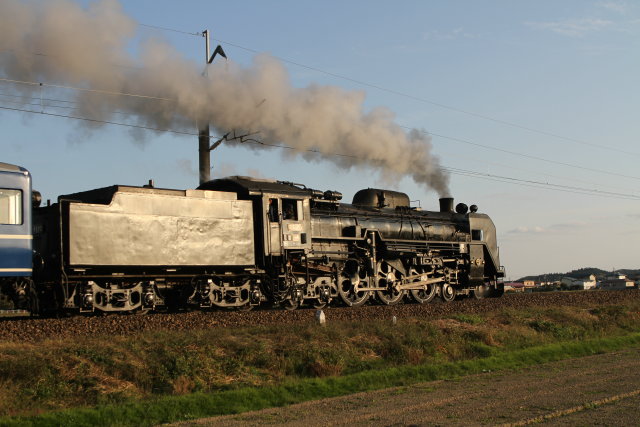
174 349 640 427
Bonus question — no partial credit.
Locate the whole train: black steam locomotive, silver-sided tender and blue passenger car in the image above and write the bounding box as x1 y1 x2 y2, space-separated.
0 164 504 314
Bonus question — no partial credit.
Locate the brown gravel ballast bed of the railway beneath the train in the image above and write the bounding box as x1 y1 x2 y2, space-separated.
0 290 640 342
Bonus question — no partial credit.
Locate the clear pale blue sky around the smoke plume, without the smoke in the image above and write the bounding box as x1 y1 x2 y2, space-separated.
0 0 640 279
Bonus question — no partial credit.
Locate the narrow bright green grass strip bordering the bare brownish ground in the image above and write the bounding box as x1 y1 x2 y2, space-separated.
0 333 640 426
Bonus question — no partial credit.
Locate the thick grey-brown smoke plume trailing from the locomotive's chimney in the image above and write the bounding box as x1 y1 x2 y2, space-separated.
0 0 448 196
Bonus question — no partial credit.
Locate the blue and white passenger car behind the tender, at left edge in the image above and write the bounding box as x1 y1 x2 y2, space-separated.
0 163 33 305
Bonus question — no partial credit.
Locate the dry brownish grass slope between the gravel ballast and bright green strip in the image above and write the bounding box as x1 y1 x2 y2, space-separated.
0 303 640 415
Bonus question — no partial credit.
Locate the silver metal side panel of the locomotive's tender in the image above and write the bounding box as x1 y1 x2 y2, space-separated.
68 190 255 266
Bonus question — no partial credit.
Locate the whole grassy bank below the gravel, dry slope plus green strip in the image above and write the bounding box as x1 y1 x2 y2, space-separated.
0 302 640 425
